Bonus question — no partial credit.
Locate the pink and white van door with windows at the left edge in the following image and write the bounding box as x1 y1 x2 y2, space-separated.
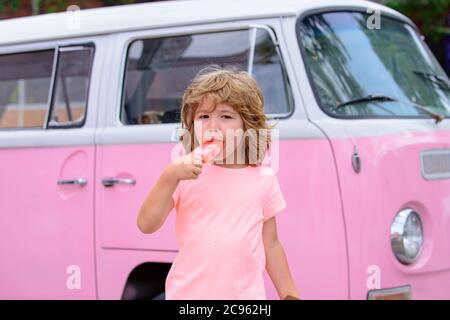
0 41 100 299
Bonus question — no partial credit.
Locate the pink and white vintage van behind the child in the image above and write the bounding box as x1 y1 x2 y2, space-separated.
0 0 450 299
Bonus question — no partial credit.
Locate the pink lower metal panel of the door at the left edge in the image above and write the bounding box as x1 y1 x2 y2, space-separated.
0 147 96 299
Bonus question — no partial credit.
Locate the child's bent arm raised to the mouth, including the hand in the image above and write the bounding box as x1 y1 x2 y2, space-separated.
137 154 202 233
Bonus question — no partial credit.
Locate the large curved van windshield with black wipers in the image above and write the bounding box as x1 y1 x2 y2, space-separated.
296 12 450 118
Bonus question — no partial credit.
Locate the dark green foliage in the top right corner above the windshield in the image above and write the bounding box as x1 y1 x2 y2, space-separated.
385 0 450 42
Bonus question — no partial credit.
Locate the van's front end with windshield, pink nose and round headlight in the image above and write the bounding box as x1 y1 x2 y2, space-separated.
296 8 450 299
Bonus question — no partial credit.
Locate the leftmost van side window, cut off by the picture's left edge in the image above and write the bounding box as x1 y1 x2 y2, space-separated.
0 50 54 129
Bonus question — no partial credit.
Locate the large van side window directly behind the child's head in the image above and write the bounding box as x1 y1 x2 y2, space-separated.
120 28 290 125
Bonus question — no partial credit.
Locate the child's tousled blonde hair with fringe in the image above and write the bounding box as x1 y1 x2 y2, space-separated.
180 65 275 166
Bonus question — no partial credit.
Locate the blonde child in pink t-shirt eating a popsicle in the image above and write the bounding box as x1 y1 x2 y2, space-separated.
137 66 299 300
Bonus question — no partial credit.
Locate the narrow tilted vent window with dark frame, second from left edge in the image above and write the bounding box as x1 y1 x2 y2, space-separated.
48 45 94 128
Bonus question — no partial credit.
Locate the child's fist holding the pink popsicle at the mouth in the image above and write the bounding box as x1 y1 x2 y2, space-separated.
166 152 203 181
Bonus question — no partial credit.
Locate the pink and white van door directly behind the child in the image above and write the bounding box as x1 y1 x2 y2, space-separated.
96 17 347 299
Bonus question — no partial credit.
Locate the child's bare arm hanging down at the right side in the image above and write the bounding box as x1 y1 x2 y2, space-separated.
262 217 300 299
